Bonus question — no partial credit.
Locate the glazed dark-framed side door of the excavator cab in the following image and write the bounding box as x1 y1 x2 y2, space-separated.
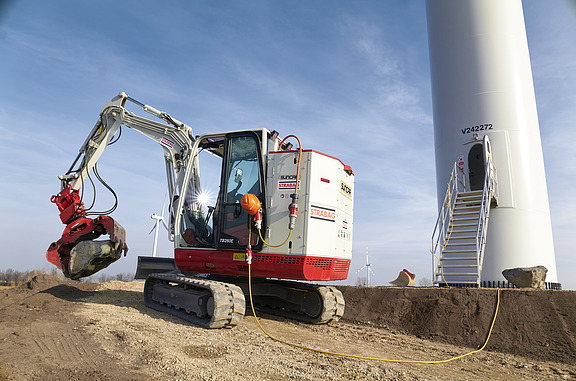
216 132 265 250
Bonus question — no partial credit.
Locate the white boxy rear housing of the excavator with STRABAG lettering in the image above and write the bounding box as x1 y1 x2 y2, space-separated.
262 151 354 259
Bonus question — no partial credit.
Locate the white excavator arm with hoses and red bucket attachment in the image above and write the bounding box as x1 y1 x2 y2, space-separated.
46 93 194 279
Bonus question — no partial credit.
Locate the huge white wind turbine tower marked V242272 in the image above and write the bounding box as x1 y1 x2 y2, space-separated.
427 0 558 283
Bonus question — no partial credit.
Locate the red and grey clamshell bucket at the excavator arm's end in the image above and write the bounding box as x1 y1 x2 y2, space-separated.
46 216 128 280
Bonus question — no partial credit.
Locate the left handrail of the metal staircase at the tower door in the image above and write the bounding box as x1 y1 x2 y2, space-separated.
430 162 469 283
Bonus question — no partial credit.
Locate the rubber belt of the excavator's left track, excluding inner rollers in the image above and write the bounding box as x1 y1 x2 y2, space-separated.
144 273 246 328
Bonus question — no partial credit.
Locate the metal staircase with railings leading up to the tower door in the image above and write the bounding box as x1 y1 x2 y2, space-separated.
431 137 497 287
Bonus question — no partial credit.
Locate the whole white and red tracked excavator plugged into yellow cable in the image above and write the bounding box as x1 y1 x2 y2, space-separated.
46 92 354 328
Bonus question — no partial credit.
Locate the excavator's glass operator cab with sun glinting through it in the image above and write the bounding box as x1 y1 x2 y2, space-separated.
179 131 264 250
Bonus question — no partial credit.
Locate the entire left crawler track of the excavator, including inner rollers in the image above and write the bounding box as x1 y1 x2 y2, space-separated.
144 273 246 328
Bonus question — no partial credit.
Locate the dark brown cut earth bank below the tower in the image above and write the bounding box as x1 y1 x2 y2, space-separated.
339 286 576 363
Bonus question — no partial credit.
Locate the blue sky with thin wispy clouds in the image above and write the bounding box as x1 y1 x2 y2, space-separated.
0 0 576 289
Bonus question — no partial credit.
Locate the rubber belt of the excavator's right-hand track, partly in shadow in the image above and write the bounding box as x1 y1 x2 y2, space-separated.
254 281 345 324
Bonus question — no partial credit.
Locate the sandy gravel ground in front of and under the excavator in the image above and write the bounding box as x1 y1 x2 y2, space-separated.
0 278 576 381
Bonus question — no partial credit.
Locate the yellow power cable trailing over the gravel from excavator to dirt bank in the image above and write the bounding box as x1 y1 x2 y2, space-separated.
248 263 500 364
